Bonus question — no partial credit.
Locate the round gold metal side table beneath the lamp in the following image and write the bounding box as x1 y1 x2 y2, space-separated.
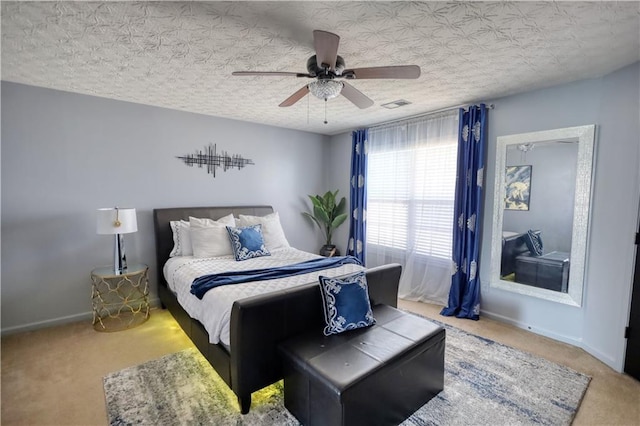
91 263 149 331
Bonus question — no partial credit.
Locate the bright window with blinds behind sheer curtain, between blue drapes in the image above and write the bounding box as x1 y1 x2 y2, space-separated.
367 114 458 261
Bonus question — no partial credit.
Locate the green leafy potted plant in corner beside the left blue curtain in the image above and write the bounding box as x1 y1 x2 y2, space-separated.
303 190 347 256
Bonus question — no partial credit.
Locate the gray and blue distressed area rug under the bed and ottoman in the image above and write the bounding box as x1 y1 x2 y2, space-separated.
104 325 591 426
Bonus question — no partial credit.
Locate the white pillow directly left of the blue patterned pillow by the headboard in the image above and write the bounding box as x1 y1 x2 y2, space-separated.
189 214 236 257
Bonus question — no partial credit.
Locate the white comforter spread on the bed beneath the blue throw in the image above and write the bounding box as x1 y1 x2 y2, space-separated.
163 248 363 347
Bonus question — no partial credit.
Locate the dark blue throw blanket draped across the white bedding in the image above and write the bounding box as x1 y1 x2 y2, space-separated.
191 256 361 299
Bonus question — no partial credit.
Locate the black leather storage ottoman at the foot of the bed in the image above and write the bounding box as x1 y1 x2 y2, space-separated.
279 305 445 426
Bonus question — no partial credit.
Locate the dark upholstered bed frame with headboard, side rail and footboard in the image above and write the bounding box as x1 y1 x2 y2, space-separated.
153 205 401 414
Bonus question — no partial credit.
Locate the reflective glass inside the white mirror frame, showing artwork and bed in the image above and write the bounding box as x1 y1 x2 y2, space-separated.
500 138 578 293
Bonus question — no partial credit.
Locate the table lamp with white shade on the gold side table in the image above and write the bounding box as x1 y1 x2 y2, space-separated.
97 207 138 275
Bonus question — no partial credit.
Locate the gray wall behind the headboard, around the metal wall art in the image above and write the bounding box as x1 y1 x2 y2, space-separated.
1 82 329 332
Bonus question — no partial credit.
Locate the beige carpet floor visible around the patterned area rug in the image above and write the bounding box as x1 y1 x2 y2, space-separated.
1 301 640 425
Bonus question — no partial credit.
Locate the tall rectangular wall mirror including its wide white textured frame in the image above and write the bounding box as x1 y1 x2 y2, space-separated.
490 125 595 306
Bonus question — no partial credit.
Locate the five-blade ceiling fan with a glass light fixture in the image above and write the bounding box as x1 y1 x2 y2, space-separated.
232 30 420 109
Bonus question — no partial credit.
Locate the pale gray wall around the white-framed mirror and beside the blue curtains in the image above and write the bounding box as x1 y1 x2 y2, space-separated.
330 63 640 371
